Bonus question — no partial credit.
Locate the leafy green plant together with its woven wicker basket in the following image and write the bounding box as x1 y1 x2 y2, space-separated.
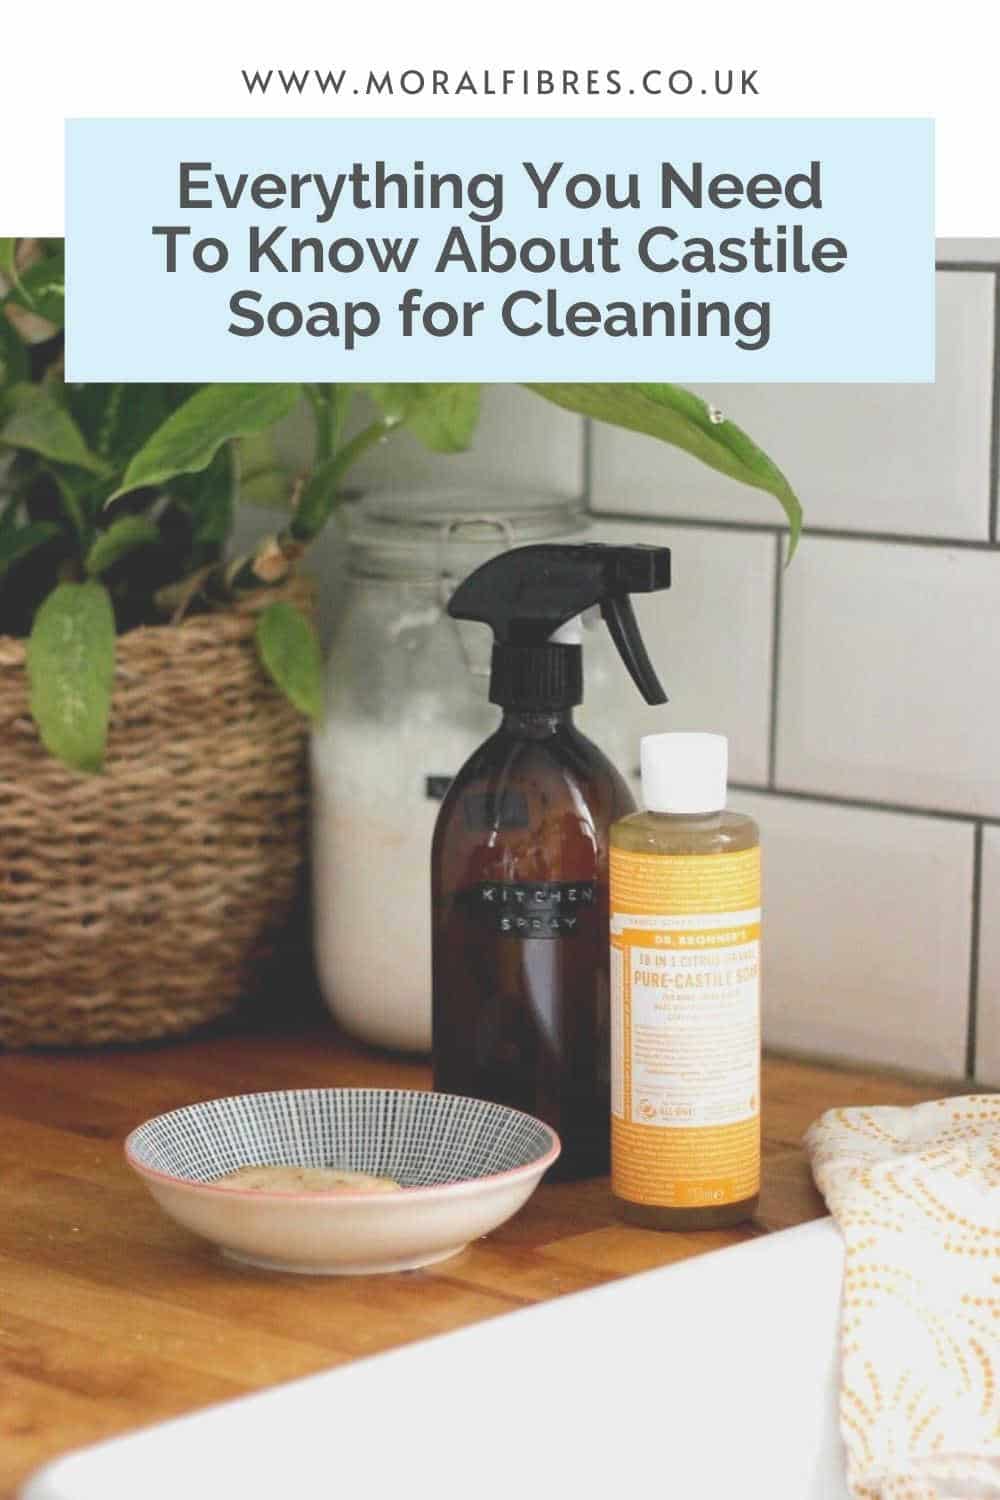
0 239 799 1046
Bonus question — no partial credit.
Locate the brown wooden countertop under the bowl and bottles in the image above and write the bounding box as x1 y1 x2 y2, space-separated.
0 1022 945 1500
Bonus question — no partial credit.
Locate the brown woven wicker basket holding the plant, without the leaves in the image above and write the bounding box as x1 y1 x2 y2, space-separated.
0 585 306 1047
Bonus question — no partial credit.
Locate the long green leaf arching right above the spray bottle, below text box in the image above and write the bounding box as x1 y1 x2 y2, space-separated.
528 384 802 557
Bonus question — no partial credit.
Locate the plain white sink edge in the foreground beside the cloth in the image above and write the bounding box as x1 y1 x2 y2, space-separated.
21 1220 847 1500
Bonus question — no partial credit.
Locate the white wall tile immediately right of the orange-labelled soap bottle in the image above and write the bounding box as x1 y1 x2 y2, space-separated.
740 792 973 1077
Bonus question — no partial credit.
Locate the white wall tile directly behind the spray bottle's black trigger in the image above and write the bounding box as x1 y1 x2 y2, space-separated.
580 522 775 785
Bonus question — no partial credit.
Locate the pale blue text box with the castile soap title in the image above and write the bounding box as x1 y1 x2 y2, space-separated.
66 120 934 381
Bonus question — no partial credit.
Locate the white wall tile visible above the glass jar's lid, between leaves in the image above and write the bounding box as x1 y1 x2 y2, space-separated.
351 386 583 497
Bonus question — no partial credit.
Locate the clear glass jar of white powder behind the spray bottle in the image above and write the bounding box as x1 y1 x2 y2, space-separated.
312 491 589 1052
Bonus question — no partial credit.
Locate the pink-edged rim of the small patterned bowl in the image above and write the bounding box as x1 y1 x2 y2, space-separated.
123 1085 562 1209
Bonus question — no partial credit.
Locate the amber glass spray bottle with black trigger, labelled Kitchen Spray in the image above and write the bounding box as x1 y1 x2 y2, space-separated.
432 545 670 1178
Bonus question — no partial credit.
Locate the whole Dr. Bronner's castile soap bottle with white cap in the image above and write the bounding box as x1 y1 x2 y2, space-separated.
610 734 760 1229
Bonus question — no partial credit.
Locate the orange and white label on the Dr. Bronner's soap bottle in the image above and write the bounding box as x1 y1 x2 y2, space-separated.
610 849 760 1208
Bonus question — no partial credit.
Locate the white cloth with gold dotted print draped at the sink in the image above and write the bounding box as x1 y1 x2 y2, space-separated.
805 1095 1000 1500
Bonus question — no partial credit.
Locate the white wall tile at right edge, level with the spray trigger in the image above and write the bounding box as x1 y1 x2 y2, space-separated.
777 537 1000 815
